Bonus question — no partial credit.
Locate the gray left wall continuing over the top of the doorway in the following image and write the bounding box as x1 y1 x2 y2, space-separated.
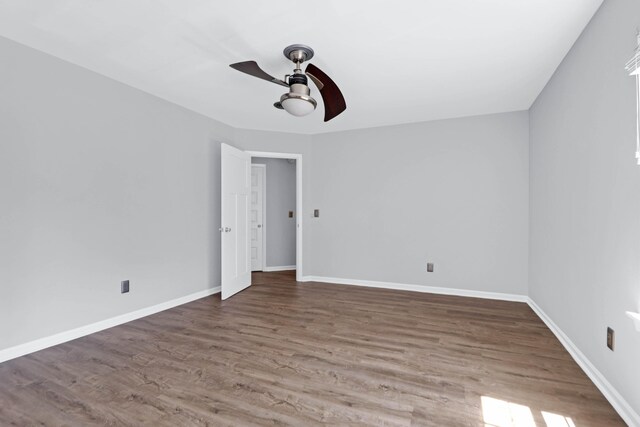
0 38 310 350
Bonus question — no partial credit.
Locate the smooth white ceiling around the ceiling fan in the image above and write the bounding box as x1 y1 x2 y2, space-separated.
0 0 602 134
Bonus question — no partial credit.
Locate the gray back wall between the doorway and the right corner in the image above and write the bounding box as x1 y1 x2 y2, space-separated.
305 112 529 295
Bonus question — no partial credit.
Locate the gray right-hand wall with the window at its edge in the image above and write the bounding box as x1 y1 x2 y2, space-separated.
529 0 640 412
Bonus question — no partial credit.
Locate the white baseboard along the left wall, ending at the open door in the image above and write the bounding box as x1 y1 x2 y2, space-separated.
0 286 220 363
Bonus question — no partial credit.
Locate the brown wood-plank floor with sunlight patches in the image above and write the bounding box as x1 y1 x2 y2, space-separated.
0 272 624 427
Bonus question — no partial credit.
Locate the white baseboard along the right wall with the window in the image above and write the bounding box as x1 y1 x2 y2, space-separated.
527 298 640 427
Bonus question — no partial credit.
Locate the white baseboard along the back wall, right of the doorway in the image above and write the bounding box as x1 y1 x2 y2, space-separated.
302 276 528 302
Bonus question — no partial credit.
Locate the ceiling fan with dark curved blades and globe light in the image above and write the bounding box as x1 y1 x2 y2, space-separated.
229 44 347 122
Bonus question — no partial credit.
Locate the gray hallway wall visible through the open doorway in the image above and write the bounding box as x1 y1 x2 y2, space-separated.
251 157 296 267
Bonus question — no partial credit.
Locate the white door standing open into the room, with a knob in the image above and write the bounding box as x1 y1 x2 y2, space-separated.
220 144 251 299
